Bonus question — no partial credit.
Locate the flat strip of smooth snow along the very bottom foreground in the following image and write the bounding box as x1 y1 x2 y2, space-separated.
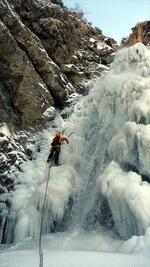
1 249 150 267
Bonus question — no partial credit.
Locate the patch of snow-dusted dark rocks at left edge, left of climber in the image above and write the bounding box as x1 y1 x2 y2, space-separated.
0 123 40 191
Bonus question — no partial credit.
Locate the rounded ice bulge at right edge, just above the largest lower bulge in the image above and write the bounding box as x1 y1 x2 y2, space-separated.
108 122 150 177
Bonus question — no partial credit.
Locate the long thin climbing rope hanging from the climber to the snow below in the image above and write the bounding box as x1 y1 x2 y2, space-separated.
39 163 51 267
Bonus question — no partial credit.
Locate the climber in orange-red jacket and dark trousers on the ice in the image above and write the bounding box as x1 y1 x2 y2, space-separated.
47 132 69 166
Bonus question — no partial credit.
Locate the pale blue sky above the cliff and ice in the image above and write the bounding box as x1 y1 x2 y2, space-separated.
63 0 150 43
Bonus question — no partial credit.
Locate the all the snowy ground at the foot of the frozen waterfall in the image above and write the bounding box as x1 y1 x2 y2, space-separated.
0 228 150 267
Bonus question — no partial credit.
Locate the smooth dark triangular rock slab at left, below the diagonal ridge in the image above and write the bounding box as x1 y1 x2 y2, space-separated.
0 21 53 126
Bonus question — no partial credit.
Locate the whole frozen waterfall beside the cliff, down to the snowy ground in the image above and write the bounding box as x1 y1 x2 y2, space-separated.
1 43 150 253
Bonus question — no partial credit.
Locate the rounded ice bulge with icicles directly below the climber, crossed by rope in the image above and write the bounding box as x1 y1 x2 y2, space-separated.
13 165 77 242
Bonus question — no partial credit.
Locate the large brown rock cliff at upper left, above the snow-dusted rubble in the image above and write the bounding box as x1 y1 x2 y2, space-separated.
0 0 116 127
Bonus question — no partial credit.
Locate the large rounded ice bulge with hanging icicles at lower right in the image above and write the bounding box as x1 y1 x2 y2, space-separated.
98 162 150 239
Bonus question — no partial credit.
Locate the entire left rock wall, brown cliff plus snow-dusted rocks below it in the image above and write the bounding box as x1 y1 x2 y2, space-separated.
0 0 117 243
